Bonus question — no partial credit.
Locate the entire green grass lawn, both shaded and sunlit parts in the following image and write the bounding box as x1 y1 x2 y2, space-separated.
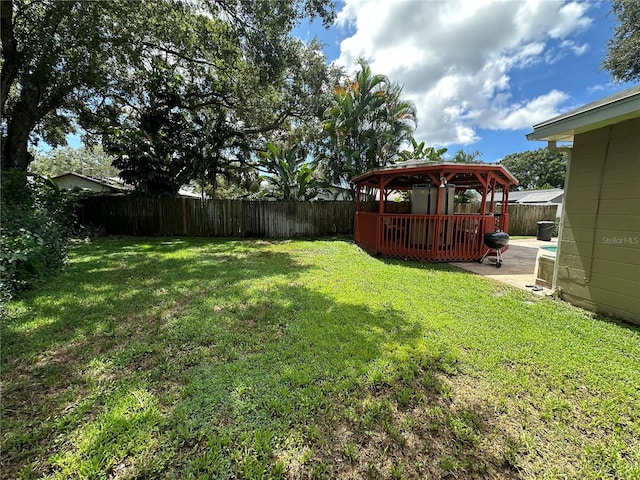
0 238 640 479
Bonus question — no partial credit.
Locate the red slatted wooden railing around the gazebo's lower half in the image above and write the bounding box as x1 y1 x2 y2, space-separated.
355 212 504 262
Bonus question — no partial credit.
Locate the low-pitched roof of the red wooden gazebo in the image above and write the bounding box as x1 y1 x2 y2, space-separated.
351 161 519 190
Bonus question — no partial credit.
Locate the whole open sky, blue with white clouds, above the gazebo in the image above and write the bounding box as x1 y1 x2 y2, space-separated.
294 0 630 162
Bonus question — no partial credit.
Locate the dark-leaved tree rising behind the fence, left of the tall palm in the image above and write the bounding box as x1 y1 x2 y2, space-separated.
99 39 336 195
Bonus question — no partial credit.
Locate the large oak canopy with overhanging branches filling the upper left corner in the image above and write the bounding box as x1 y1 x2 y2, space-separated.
0 0 333 171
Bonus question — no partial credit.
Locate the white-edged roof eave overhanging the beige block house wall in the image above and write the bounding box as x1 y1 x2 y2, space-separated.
527 85 640 142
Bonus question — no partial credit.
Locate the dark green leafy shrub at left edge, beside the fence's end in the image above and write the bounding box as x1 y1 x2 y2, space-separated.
0 170 74 302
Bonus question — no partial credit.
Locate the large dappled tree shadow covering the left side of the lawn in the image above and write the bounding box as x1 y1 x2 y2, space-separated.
2 239 510 478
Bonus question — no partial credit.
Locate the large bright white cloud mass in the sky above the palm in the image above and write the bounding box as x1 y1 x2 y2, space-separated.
337 0 591 145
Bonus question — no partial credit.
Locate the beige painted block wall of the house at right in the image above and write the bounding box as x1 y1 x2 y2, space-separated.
555 119 640 324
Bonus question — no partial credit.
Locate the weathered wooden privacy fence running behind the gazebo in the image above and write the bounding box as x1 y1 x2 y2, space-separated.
78 196 556 238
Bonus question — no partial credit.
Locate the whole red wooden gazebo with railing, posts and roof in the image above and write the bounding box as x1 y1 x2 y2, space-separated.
351 162 518 262
